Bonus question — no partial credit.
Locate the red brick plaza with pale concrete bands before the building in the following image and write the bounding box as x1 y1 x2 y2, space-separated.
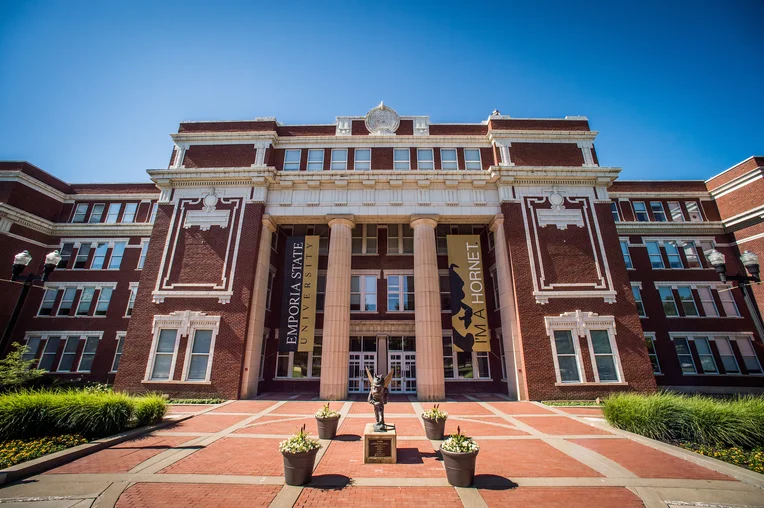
0 395 764 508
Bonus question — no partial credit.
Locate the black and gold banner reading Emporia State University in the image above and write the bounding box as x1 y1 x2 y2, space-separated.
279 236 318 353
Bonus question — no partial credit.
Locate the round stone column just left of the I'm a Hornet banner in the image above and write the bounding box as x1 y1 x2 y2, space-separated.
411 216 446 400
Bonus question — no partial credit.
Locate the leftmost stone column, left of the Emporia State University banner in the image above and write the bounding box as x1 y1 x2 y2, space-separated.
241 215 276 399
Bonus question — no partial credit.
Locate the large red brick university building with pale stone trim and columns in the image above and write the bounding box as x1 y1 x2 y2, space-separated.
0 105 764 400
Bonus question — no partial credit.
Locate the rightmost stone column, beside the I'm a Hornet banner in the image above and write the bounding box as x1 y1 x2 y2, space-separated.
490 214 527 400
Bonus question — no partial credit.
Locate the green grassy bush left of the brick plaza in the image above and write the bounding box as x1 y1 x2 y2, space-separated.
0 389 164 440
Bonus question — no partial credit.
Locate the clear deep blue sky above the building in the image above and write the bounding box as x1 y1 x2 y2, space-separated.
0 0 764 183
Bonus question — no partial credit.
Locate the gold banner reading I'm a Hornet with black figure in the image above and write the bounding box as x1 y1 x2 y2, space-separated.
446 235 491 352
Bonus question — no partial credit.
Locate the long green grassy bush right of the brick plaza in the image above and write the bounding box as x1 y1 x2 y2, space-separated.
603 393 764 449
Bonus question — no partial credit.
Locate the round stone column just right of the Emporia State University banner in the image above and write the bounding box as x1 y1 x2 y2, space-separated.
321 216 355 400
